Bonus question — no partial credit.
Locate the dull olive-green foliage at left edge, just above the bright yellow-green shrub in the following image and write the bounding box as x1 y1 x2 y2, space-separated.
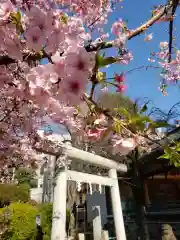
0 184 29 207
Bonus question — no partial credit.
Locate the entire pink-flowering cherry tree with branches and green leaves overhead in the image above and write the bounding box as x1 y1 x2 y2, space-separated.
0 0 180 167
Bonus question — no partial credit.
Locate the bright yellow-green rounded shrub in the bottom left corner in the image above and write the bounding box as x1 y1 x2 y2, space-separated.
0 203 38 240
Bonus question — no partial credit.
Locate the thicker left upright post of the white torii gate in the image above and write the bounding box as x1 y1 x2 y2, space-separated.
51 168 67 240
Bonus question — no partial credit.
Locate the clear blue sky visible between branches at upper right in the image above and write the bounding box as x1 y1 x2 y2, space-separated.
102 0 180 111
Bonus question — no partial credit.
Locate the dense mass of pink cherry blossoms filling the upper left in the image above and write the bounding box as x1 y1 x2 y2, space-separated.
0 0 135 161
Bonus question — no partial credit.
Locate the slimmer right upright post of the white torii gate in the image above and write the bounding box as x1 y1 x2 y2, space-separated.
109 169 126 240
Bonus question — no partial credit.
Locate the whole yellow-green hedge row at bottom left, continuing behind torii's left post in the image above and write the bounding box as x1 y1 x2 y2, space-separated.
0 202 70 240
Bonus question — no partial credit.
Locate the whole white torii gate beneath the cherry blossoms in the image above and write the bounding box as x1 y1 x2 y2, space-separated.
51 145 127 240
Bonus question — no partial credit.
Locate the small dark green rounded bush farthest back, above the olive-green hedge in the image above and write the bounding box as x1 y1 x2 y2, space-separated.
15 168 37 188
